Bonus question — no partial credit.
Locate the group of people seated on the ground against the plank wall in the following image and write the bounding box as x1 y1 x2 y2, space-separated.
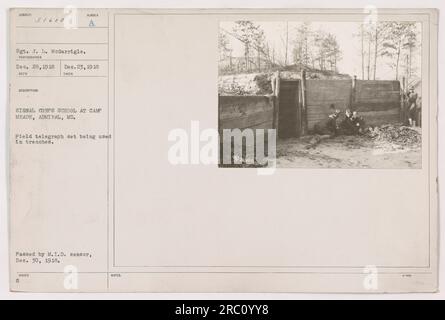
314 104 365 137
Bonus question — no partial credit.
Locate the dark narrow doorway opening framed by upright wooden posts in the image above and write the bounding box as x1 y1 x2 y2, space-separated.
278 80 301 139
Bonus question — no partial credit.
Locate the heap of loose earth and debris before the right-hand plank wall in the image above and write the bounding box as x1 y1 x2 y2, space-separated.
366 125 422 147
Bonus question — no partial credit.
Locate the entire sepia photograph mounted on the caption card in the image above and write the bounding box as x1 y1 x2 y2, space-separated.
218 19 422 169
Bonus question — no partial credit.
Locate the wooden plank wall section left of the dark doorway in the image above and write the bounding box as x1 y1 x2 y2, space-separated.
219 96 274 130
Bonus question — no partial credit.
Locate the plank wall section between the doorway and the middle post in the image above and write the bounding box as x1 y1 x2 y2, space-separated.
306 80 352 131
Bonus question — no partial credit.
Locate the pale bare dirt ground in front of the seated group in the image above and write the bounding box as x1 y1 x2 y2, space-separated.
277 131 422 169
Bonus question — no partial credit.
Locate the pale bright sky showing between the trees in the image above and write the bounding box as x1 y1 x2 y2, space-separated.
221 21 421 80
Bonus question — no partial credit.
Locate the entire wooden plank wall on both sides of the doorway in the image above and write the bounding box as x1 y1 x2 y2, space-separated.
219 80 401 138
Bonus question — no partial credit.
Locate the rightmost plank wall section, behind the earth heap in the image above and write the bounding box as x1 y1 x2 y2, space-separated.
352 80 401 126
